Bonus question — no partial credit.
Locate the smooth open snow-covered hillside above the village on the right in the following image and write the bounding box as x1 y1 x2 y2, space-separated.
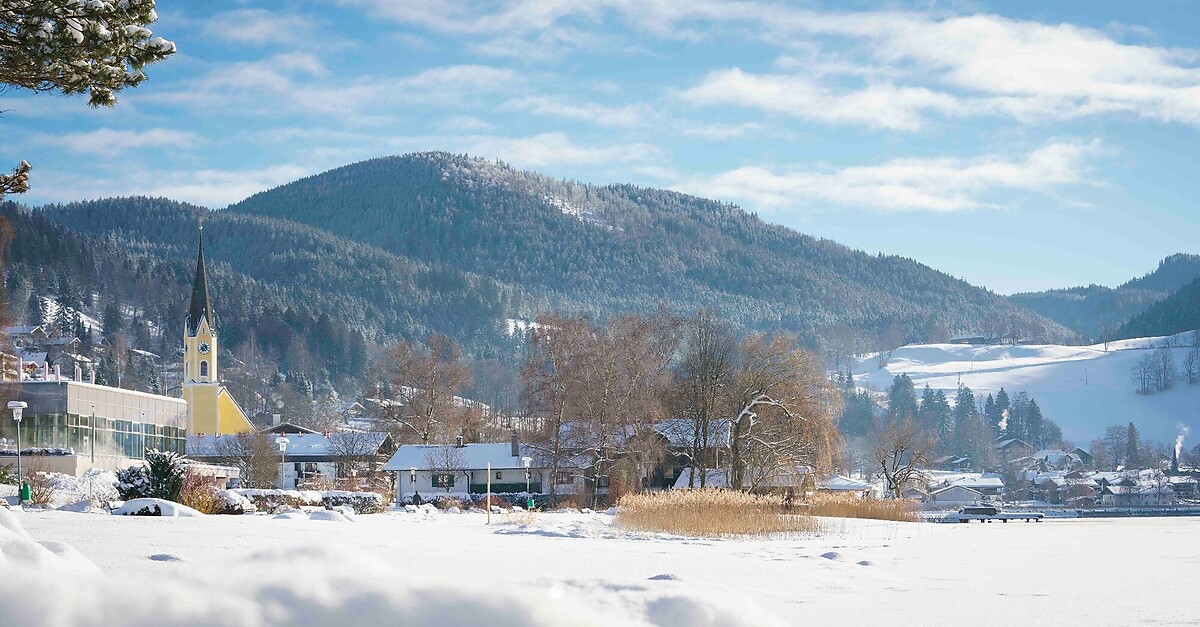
854 332 1200 448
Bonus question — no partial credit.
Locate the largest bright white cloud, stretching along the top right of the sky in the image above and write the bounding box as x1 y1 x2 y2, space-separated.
342 0 1200 130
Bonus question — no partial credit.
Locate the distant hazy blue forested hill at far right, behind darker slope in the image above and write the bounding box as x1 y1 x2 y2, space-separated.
1008 253 1200 341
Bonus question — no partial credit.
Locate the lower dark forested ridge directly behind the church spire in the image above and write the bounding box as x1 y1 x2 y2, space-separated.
2 198 523 389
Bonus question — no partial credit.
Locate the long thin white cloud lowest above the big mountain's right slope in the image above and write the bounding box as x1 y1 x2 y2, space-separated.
673 141 1104 213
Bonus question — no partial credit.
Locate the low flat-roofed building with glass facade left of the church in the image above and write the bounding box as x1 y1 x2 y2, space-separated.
0 381 187 459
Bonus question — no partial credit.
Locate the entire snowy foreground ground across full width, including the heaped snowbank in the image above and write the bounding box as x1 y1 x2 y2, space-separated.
0 504 1200 626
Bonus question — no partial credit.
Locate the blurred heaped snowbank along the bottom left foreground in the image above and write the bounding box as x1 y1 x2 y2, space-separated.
0 512 782 627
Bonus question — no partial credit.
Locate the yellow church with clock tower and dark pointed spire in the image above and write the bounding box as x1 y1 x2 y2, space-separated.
182 226 254 435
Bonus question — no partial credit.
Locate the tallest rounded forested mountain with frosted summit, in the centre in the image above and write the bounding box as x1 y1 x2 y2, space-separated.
227 153 1070 344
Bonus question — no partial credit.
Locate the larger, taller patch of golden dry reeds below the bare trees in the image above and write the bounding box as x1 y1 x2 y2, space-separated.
617 489 821 538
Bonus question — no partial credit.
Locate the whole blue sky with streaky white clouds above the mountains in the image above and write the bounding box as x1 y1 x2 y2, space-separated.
0 0 1200 294
